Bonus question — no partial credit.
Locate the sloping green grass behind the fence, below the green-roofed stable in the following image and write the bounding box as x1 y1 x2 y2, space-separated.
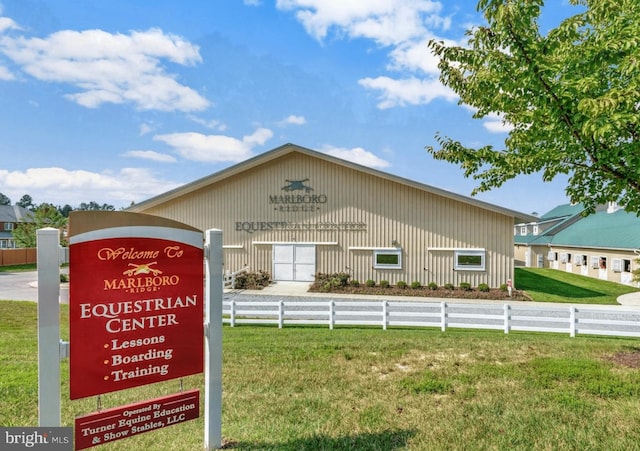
514 268 638 305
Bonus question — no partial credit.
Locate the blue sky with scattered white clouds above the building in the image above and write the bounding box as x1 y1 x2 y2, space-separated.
0 0 576 213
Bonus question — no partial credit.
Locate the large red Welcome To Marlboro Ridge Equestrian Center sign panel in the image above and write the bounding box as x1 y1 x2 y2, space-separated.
69 212 204 399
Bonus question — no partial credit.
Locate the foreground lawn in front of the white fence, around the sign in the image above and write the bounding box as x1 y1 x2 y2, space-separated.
0 301 640 451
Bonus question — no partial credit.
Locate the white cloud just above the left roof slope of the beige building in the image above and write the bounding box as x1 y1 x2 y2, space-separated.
158 128 273 163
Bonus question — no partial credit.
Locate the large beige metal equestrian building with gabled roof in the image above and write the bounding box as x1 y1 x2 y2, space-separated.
128 144 536 287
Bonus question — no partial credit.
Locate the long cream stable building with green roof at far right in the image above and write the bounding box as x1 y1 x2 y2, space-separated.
514 203 640 286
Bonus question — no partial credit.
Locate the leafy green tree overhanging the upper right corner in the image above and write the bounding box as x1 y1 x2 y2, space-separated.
427 0 640 213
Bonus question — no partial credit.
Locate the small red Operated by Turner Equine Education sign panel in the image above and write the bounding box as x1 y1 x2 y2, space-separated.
74 390 200 449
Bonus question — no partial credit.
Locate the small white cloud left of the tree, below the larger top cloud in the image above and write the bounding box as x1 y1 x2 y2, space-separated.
358 77 458 109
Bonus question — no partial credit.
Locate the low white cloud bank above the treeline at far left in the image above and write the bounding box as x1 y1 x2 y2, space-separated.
0 167 180 208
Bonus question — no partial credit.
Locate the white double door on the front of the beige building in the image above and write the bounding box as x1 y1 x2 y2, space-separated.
273 244 316 282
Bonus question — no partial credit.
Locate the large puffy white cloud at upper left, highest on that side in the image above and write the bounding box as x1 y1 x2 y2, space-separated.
0 29 209 111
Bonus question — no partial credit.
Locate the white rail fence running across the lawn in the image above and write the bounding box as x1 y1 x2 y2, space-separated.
223 300 640 337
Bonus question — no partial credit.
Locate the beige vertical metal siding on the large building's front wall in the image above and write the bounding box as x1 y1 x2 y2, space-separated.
138 153 514 287
